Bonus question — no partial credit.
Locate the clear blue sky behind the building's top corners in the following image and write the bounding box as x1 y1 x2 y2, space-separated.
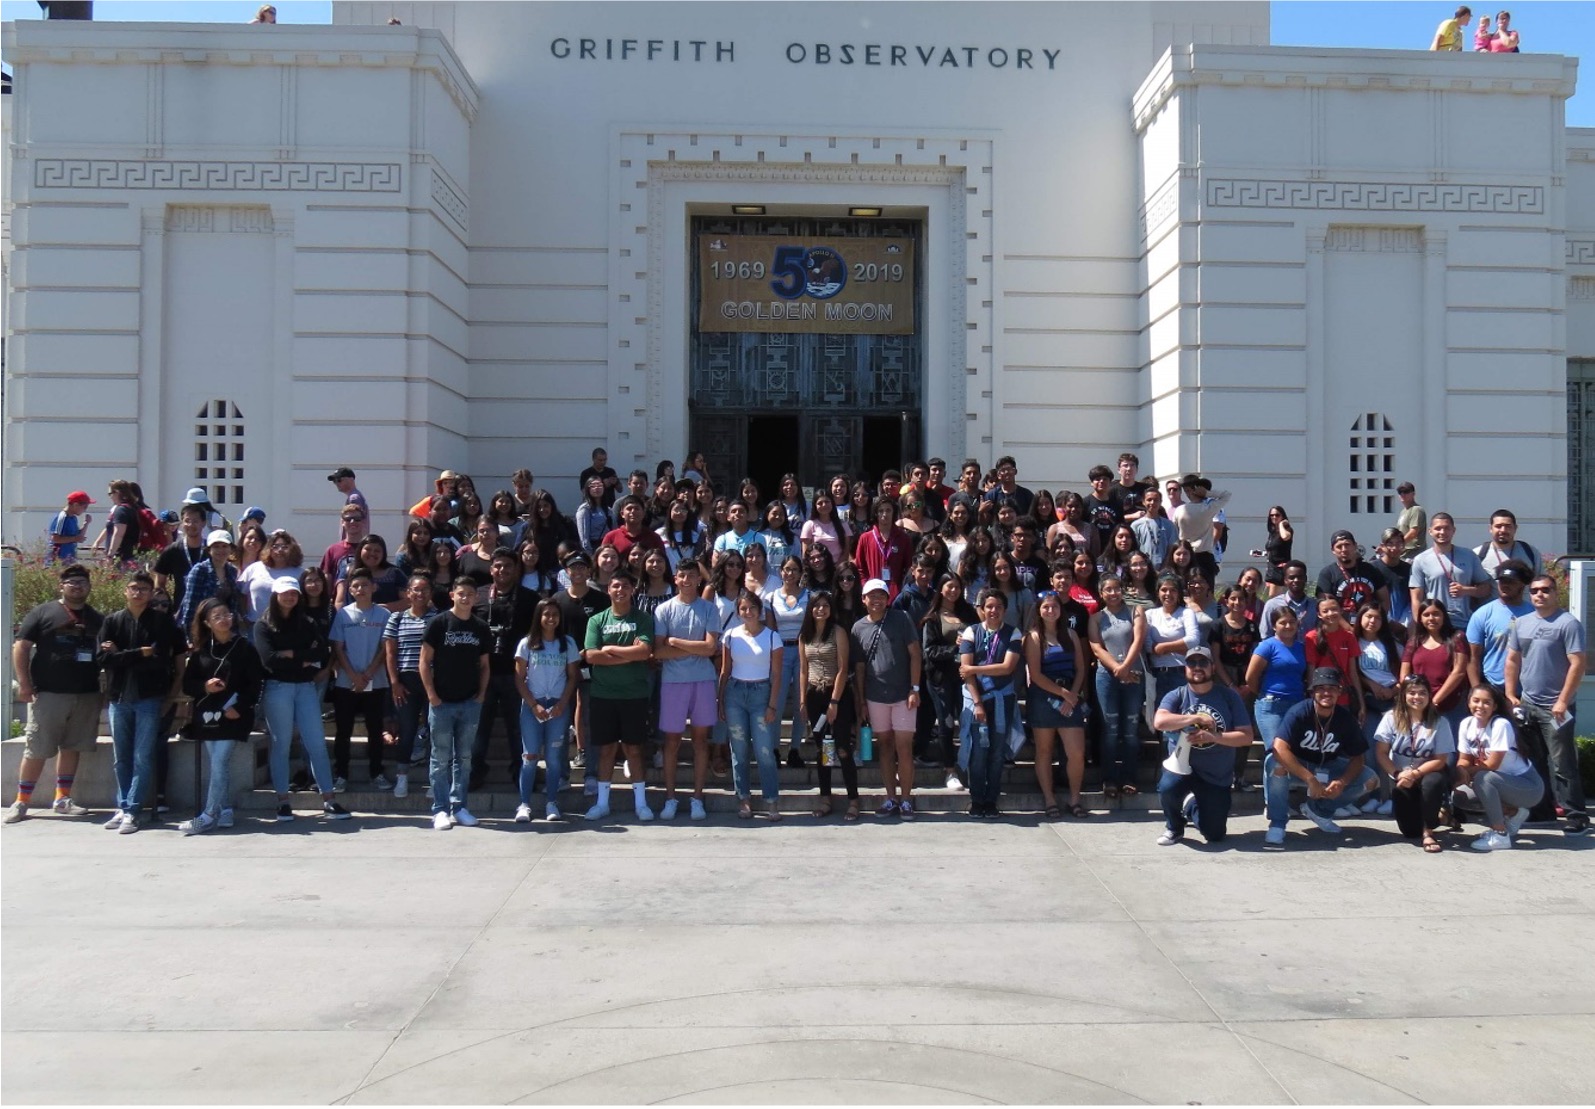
5 0 1595 128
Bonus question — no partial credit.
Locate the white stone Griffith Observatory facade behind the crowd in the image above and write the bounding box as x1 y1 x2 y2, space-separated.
3 2 1595 565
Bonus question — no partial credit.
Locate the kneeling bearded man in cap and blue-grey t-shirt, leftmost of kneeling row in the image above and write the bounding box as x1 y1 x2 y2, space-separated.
1152 646 1252 847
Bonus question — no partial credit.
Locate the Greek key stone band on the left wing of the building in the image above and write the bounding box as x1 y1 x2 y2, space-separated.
33 158 404 193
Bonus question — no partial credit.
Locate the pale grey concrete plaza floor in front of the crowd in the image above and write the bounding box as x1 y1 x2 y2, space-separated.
0 812 1595 1104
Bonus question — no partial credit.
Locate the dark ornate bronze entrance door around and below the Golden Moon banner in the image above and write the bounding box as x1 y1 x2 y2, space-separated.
687 217 924 499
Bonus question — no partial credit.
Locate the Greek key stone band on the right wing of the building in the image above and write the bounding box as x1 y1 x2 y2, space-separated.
1206 177 1546 215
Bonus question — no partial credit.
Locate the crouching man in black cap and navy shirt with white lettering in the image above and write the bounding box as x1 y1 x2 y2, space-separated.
1263 667 1380 844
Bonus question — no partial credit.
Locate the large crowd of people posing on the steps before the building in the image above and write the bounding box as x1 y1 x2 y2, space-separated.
5 448 1589 852
